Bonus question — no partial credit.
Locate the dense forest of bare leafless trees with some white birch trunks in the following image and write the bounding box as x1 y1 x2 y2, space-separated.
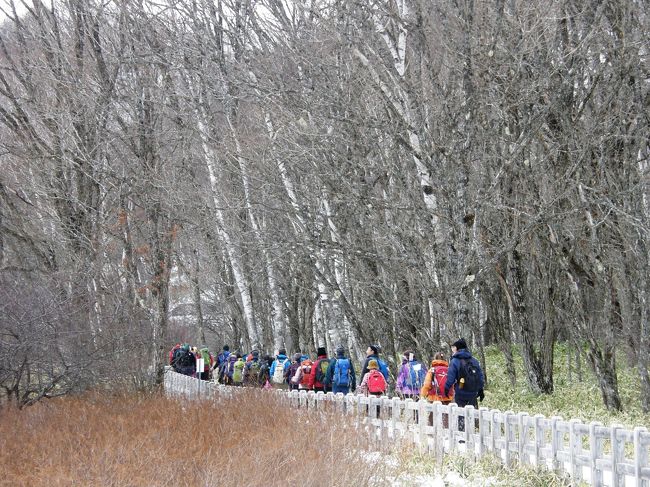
0 0 650 412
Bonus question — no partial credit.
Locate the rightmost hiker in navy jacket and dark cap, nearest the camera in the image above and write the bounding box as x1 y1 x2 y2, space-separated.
445 338 485 431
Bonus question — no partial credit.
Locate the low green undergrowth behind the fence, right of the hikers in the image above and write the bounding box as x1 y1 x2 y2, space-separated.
481 343 650 427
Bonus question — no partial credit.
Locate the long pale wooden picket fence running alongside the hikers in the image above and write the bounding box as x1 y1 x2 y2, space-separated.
165 369 650 487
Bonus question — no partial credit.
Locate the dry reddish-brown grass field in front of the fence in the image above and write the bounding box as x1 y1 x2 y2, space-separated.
0 390 388 487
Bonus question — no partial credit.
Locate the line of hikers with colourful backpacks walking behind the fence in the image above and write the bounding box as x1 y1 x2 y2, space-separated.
169 338 484 416
